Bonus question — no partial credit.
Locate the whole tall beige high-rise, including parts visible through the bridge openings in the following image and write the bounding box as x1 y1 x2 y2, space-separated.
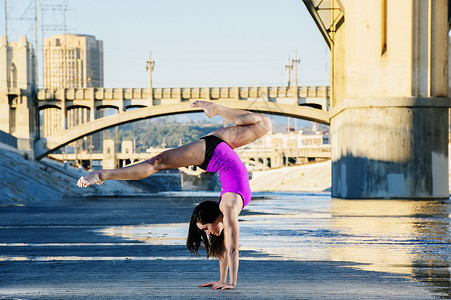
42 34 103 163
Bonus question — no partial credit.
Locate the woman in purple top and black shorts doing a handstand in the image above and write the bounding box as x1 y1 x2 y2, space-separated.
78 101 271 289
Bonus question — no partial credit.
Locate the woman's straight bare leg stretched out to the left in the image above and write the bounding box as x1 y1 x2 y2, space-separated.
77 140 205 187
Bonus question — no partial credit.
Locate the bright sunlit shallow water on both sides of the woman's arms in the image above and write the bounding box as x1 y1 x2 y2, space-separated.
101 193 451 298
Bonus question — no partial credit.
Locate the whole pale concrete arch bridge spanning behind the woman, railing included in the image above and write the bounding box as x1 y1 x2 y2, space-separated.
34 86 329 159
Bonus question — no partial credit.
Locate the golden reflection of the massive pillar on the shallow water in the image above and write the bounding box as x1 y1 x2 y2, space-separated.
330 199 451 297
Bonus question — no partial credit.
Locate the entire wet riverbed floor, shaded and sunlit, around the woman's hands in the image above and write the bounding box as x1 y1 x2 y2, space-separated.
0 192 451 299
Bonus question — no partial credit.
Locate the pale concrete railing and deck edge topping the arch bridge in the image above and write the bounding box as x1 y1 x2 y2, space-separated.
37 86 330 116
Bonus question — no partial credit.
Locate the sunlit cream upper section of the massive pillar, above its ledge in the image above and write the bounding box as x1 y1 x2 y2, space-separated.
336 0 448 99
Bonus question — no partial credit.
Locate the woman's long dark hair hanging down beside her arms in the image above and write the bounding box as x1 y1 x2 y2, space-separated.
186 201 224 258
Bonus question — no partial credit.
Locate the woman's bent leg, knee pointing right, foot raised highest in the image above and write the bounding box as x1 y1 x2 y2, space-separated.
191 101 272 148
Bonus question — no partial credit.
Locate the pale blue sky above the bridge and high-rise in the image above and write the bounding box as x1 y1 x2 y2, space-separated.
4 0 330 123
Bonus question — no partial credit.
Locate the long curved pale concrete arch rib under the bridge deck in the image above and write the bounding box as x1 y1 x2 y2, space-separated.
34 100 329 159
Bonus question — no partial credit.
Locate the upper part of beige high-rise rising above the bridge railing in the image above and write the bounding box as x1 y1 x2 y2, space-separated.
44 34 103 89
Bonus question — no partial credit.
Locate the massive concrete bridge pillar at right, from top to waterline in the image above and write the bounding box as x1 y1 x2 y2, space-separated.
330 0 450 199
